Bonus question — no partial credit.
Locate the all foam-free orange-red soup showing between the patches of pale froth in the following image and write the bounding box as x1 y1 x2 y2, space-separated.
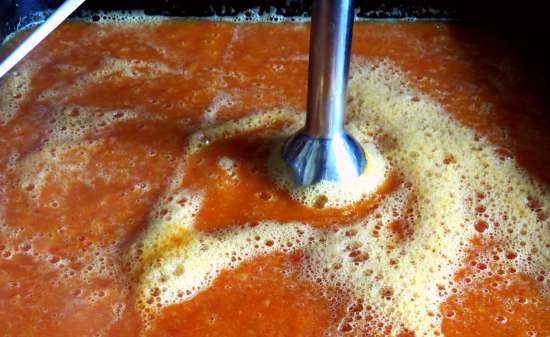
0 21 550 337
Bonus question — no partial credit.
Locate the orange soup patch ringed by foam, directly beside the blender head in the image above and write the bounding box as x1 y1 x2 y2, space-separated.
183 135 396 231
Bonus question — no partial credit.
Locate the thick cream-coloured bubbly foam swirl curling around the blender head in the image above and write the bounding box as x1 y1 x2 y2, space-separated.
132 60 550 336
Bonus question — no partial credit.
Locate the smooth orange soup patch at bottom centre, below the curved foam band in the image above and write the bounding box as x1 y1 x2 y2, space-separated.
151 255 341 337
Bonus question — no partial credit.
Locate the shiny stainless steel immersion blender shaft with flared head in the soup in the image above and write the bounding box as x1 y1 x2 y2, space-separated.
282 0 366 185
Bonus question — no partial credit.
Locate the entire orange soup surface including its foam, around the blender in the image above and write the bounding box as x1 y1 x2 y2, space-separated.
0 20 550 337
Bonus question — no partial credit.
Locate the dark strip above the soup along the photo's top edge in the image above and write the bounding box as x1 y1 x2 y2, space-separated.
0 0 549 37
